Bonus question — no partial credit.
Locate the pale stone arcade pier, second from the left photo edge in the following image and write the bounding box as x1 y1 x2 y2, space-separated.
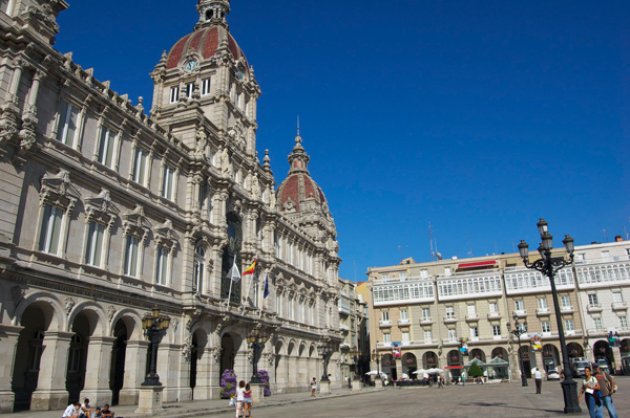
31 331 74 411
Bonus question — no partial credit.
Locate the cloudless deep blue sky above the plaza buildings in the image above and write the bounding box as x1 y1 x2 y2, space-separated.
56 0 630 280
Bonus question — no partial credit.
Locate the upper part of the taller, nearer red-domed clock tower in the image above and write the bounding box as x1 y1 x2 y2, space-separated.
151 0 261 156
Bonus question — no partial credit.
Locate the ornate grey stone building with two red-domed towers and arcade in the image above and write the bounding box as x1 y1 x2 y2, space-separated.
0 0 341 412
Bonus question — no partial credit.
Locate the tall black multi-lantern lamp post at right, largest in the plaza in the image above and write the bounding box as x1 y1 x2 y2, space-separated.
518 218 581 414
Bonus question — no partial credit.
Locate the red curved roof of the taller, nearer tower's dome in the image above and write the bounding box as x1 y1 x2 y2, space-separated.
166 25 247 69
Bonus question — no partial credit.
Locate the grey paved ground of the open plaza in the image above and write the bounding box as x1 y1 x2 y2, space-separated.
0 377 630 418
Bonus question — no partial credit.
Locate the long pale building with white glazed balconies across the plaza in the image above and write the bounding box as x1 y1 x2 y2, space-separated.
368 240 630 378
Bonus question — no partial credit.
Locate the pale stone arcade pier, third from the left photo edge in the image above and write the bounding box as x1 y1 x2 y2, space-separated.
80 337 115 405
